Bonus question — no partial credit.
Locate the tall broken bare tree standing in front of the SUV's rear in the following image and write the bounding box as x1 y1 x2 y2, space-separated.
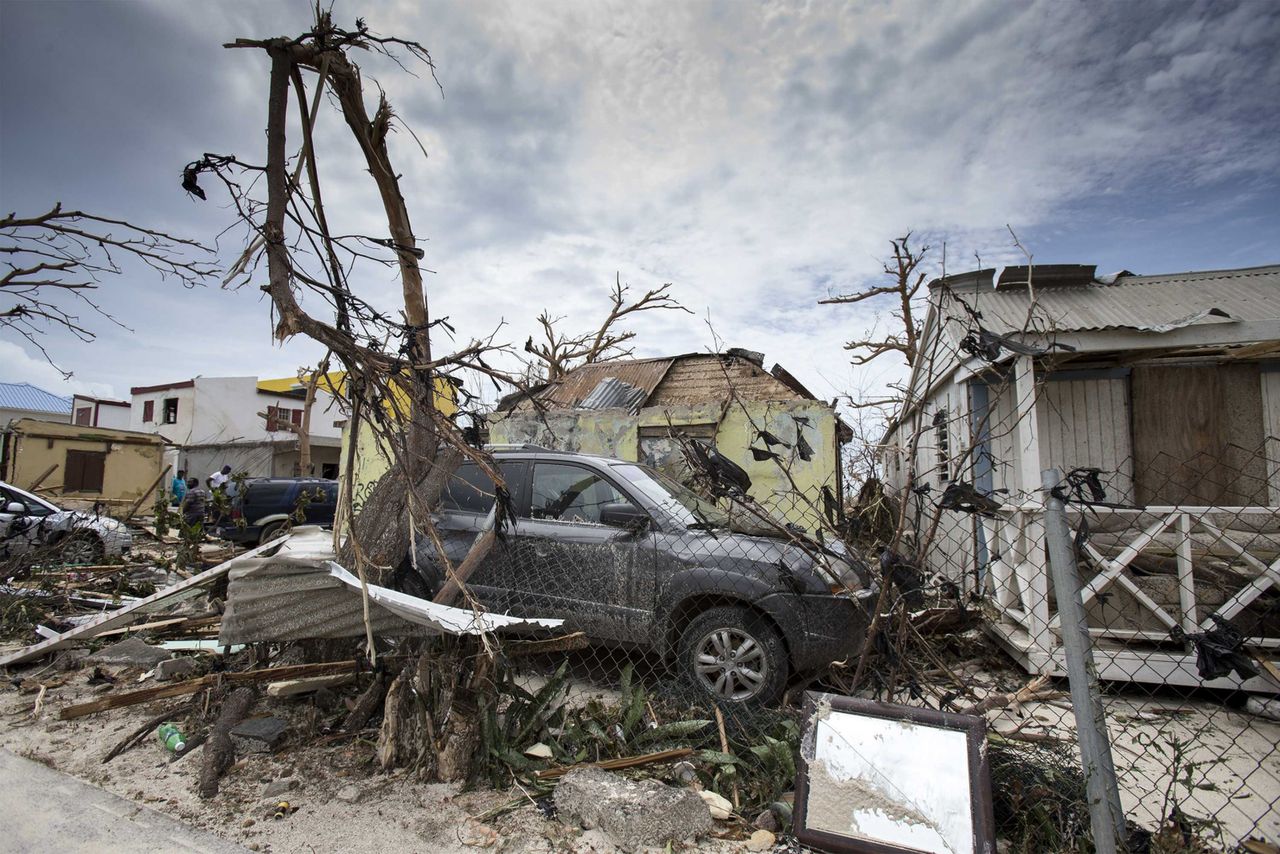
183 6 535 778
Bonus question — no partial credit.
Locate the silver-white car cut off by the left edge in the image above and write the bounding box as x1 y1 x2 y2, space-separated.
0 480 133 563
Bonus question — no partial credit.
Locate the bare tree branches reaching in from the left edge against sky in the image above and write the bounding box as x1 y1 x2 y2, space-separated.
0 202 215 379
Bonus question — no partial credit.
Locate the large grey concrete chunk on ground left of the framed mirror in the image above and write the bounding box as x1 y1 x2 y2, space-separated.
554 767 712 851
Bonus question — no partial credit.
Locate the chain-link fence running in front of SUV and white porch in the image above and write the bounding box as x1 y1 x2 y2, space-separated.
409 437 1280 851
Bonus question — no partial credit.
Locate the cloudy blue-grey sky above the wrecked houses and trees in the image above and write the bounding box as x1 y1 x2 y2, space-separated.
0 0 1280 407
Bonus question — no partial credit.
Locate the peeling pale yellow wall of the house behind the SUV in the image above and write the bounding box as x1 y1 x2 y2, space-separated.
489 401 840 530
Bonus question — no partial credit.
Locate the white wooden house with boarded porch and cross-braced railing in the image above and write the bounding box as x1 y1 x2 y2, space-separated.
881 265 1280 690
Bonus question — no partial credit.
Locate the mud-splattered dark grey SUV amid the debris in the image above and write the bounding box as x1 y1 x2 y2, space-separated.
401 446 872 704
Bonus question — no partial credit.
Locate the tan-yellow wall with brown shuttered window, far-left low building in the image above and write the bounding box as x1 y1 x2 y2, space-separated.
5 420 165 504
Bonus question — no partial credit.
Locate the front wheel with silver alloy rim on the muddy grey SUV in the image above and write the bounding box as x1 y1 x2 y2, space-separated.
678 606 788 705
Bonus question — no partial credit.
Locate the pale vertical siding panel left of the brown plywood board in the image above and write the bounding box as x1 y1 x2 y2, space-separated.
1036 376 1133 502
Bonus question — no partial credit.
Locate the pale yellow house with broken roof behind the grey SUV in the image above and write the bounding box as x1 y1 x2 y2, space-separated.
489 348 852 528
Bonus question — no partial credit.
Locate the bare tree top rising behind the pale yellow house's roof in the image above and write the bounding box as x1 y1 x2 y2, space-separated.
525 274 692 382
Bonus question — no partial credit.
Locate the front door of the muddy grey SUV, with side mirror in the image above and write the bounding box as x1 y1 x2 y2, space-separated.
512 461 654 643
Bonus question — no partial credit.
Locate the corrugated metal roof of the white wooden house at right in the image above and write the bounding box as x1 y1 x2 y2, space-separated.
943 265 1280 334
